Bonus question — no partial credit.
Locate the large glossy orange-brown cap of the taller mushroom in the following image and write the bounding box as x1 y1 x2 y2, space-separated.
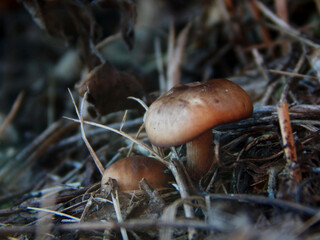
145 79 253 147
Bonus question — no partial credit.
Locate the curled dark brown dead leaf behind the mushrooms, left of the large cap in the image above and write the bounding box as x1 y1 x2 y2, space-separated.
76 62 144 115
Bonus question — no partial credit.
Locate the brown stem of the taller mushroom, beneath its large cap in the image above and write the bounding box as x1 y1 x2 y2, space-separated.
186 130 214 180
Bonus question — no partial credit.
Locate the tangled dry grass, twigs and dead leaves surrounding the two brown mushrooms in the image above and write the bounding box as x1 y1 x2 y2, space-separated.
0 0 320 240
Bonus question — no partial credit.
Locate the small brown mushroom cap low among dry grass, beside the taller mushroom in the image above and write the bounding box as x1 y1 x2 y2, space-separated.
101 156 169 191
